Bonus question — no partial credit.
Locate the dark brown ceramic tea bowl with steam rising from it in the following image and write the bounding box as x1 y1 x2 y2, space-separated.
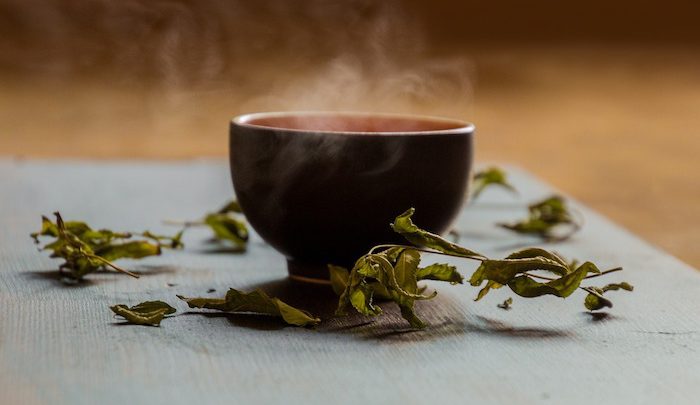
229 112 474 280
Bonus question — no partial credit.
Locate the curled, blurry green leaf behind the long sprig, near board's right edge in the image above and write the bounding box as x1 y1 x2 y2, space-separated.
498 195 581 241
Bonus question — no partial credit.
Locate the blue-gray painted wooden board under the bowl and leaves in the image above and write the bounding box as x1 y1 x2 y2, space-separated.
0 160 700 404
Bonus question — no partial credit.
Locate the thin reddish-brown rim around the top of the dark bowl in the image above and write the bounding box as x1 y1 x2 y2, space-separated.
231 110 476 136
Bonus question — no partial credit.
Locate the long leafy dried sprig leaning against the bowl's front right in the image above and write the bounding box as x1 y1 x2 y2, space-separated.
329 208 631 328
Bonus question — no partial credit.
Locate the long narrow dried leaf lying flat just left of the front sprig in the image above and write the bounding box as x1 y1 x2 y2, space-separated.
178 288 321 326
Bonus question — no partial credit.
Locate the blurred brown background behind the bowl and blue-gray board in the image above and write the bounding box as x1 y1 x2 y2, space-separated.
0 0 700 267
